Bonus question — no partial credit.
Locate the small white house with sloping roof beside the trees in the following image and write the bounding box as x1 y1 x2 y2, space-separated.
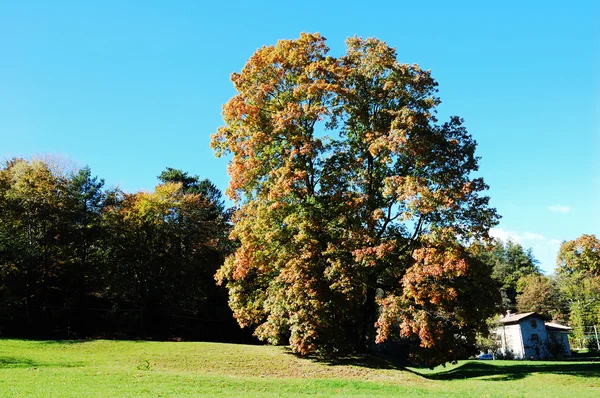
494 312 572 359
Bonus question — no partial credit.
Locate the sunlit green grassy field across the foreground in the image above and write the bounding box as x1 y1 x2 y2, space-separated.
0 340 600 398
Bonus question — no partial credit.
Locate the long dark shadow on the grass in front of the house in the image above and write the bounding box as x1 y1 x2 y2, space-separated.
406 362 600 381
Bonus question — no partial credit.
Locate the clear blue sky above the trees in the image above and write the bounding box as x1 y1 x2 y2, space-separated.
0 0 600 271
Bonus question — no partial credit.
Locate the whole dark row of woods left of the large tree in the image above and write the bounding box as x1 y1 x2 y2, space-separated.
0 159 248 340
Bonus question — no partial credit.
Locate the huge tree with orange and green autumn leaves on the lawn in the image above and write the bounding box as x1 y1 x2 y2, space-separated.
212 34 497 363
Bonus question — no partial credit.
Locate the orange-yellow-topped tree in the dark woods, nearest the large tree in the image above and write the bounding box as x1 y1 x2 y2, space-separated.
106 183 228 336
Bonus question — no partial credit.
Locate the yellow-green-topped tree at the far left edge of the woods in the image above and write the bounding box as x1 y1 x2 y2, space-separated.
0 159 68 333
